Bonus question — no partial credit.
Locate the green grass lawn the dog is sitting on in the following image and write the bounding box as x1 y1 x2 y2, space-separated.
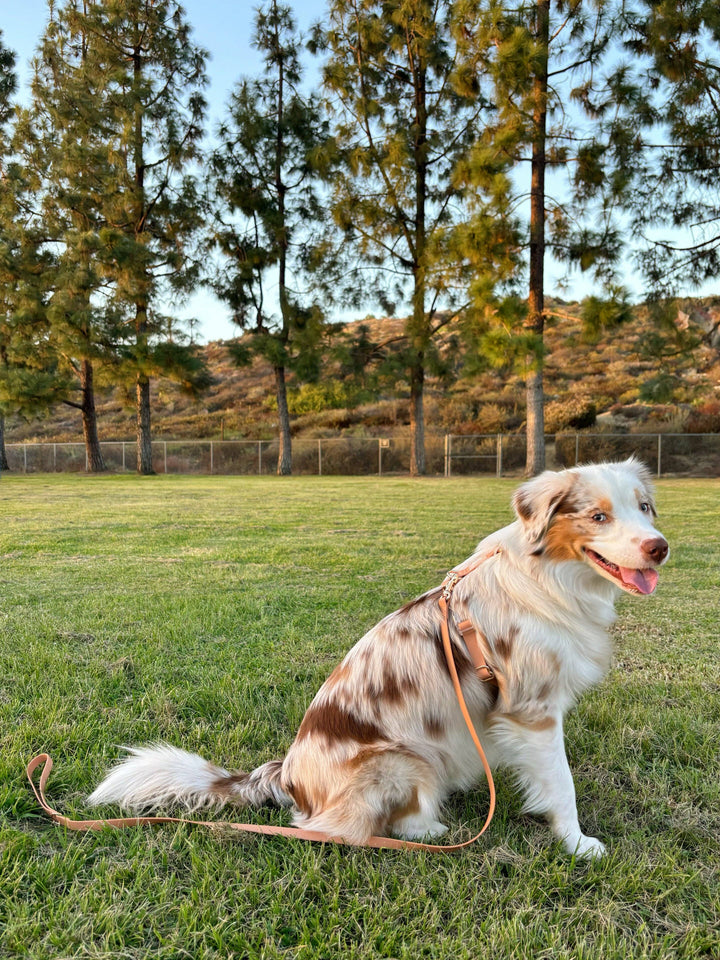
0 475 720 960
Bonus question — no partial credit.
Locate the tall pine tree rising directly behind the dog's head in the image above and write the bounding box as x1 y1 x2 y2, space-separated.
466 0 618 475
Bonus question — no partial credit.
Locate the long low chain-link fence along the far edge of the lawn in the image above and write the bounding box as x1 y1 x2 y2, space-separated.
1 432 720 477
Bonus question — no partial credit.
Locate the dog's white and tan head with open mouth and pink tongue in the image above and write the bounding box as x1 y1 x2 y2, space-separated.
513 458 669 594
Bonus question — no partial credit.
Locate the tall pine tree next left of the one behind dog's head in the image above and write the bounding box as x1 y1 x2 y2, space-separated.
315 0 496 474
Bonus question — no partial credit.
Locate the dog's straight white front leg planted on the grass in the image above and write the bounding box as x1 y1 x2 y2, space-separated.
492 713 605 857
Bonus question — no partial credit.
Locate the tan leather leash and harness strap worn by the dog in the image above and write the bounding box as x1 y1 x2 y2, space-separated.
26 550 498 853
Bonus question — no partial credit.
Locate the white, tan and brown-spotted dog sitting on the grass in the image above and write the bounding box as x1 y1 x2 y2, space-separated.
89 459 668 857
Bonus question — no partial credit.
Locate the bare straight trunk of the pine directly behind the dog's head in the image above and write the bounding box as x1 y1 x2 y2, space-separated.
525 0 550 476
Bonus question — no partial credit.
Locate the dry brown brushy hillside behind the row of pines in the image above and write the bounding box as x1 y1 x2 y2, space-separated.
6 300 720 442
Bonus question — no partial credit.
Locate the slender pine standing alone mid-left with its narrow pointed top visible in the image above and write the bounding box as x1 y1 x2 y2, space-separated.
211 0 327 475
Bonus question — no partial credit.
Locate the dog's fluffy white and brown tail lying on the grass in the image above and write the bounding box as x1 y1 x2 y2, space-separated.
88 743 292 810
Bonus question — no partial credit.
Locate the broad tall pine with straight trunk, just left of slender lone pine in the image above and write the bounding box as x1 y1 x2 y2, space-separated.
23 0 207 473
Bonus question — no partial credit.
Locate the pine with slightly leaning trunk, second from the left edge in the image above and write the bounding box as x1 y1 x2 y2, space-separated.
19 3 119 472
